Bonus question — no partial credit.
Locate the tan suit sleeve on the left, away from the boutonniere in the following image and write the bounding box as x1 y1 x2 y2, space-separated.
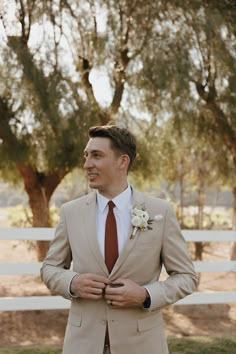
41 207 77 299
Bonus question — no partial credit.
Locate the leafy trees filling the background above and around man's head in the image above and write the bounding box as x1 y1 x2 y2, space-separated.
0 0 236 224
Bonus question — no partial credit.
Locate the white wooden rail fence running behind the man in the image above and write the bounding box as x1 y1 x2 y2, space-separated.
0 228 236 311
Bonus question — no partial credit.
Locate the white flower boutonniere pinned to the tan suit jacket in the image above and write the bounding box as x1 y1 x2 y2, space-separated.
130 205 153 239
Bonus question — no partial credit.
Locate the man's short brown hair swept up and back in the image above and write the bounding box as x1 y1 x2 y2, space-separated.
88 125 136 170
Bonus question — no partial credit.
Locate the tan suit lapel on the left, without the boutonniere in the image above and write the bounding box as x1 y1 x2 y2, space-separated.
84 192 109 275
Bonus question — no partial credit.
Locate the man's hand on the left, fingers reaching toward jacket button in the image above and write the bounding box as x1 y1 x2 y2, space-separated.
70 273 111 300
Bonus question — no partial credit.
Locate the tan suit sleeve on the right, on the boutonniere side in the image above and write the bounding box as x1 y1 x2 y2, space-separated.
145 205 198 311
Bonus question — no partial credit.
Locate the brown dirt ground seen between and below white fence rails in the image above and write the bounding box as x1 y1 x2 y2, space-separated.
0 234 236 347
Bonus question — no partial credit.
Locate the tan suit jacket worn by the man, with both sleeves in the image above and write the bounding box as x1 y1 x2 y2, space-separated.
41 190 197 354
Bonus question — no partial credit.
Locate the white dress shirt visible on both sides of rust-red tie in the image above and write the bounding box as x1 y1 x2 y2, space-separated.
96 185 132 257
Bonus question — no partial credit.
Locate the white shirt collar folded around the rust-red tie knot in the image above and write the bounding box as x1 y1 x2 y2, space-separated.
97 185 132 212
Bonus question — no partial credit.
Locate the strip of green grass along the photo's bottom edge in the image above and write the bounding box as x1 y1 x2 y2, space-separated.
0 336 236 354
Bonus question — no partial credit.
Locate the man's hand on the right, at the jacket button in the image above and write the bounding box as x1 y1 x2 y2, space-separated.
105 278 148 307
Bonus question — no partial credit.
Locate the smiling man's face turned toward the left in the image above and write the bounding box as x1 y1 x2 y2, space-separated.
84 137 122 197
